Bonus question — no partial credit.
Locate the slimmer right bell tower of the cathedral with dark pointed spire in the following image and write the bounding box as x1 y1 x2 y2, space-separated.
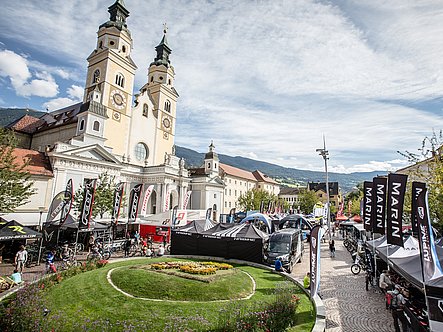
146 24 178 165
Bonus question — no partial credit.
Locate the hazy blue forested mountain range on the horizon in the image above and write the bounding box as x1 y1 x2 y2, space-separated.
175 146 387 193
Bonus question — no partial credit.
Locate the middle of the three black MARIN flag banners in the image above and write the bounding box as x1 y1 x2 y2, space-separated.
372 177 388 234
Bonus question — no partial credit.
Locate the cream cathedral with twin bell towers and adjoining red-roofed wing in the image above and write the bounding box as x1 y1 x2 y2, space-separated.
5 0 279 225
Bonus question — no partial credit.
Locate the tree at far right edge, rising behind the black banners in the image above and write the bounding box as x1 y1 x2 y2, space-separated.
398 130 443 231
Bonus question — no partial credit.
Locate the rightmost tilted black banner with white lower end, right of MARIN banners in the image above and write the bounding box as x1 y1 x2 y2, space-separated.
415 188 443 283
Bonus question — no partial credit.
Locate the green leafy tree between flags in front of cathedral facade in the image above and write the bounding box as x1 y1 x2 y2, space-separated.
74 172 118 218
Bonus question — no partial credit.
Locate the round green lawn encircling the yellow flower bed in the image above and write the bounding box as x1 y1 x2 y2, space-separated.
14 258 315 331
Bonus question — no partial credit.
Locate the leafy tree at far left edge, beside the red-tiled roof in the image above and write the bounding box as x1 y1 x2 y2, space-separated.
0 128 36 213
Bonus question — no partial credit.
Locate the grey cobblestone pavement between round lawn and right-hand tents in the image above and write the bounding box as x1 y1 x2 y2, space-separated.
293 236 395 332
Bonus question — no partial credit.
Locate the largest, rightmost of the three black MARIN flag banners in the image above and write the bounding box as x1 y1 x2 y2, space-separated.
386 173 408 247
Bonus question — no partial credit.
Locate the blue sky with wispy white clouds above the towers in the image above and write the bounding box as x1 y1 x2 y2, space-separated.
0 0 443 172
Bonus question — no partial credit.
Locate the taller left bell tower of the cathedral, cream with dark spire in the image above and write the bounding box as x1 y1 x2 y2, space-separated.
83 0 137 156
